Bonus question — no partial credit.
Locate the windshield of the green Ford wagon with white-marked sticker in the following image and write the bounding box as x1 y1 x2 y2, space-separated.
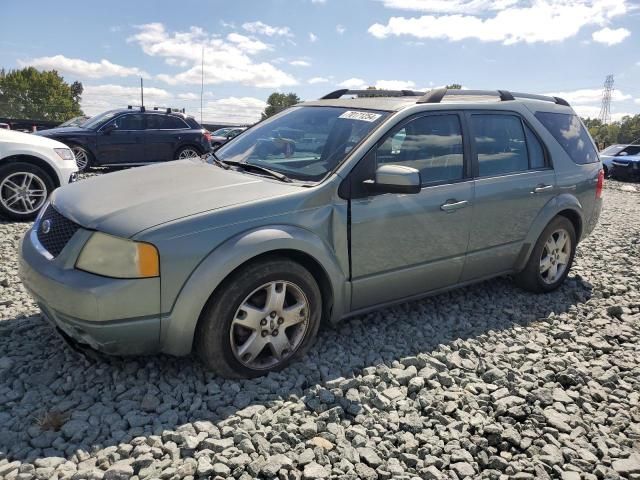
216 107 389 181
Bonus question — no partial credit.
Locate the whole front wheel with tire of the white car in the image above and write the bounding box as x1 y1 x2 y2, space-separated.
0 162 55 221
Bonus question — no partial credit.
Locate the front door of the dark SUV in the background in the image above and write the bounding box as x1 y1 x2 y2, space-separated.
97 113 145 165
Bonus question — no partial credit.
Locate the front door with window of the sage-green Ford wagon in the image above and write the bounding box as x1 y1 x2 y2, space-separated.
351 113 473 310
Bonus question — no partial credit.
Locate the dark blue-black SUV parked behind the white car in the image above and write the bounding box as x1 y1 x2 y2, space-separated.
37 106 211 171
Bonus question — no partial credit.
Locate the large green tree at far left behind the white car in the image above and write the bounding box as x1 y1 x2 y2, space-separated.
0 67 83 122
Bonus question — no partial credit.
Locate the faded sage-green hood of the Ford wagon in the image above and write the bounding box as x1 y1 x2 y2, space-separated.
51 159 301 237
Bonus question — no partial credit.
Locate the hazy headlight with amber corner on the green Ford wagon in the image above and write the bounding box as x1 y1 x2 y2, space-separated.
76 232 160 278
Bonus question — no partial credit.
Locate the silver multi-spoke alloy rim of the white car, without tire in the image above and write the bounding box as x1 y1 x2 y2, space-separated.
0 172 48 215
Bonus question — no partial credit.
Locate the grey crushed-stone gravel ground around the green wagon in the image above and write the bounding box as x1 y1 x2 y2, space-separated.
0 181 640 480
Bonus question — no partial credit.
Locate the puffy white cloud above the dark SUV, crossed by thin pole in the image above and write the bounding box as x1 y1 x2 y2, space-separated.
129 23 297 88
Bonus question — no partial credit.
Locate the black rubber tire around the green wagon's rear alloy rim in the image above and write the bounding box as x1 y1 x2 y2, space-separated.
514 216 577 293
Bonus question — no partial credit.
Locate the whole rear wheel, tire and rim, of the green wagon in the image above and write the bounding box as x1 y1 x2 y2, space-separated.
515 216 577 293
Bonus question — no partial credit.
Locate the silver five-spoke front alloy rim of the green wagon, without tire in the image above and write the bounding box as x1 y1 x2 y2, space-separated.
229 280 309 370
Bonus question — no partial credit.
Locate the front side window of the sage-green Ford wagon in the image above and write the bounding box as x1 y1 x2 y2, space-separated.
376 115 464 184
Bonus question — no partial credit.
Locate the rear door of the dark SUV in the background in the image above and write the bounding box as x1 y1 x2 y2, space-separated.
145 113 189 162
